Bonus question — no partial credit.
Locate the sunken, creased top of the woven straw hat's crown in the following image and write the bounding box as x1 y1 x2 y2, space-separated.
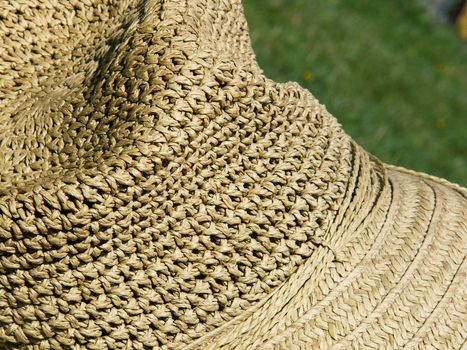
0 0 258 188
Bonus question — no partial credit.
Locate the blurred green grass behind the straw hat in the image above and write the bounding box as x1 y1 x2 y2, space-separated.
244 0 467 186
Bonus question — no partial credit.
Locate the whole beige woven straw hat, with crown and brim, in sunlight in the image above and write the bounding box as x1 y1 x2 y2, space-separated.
0 0 467 350
